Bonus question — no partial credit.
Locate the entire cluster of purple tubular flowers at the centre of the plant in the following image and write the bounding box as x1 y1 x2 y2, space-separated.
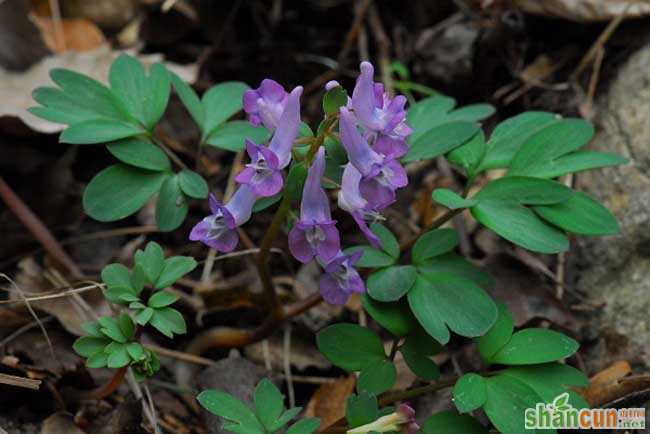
190 62 411 304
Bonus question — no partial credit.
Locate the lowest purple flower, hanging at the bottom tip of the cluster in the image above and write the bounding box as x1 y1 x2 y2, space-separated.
320 251 366 304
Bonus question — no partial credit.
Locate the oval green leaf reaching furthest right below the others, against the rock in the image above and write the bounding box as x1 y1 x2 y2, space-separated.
533 192 620 235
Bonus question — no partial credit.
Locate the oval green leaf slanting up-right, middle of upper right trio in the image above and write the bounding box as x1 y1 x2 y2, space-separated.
508 119 594 176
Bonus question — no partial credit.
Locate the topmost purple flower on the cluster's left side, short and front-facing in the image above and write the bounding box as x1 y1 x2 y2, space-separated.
243 78 289 131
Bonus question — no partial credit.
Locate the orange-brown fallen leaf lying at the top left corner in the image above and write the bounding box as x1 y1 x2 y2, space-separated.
32 15 106 53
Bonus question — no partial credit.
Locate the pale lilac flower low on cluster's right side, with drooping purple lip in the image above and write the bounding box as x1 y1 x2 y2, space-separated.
338 163 384 249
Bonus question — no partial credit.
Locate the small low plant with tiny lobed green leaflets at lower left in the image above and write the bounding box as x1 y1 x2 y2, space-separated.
74 242 196 386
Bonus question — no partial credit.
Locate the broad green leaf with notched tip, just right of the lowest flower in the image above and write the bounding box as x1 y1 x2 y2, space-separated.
408 273 497 345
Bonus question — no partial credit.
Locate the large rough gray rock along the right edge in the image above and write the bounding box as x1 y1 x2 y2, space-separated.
573 46 650 369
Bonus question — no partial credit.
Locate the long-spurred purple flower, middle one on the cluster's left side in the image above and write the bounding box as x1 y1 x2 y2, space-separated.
235 86 302 197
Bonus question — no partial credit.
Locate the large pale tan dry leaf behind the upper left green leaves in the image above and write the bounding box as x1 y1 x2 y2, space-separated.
0 45 198 133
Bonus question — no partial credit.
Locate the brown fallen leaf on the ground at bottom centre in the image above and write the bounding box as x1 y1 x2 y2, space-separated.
305 375 357 427
